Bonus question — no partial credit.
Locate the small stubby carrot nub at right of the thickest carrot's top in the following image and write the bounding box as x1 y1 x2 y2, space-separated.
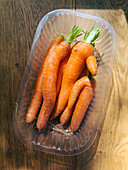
86 56 97 76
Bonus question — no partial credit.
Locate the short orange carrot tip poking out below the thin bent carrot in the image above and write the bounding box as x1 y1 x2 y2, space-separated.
60 106 73 125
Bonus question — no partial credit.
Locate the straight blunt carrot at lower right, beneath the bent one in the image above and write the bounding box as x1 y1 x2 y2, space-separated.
70 79 96 132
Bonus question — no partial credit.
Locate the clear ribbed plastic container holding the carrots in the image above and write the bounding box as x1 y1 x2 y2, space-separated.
13 9 117 156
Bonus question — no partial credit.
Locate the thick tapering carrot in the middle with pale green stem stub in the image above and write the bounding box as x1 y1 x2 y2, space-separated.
51 28 100 119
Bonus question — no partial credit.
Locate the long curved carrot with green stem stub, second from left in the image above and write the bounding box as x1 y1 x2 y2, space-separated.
36 26 81 130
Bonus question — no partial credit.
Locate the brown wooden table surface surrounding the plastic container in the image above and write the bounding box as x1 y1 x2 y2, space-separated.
0 0 128 170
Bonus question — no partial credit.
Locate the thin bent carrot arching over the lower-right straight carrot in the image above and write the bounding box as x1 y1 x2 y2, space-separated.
68 76 92 110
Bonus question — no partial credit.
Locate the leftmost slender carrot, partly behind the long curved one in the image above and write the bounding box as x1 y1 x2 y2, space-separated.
26 34 64 123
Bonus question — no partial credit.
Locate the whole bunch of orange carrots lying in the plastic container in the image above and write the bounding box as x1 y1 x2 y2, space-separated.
26 26 100 132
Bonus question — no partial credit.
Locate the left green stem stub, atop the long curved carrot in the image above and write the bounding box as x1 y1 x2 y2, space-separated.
66 26 82 44
